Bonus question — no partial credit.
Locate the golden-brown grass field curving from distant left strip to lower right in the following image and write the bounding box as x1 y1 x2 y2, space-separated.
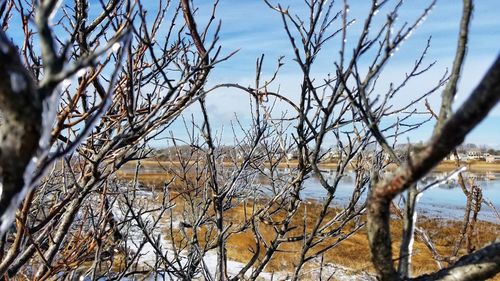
118 171 500 280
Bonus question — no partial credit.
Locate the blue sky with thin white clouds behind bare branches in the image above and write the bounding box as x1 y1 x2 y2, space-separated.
171 0 500 149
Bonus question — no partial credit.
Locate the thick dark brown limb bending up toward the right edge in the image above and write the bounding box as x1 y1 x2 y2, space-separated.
367 56 500 280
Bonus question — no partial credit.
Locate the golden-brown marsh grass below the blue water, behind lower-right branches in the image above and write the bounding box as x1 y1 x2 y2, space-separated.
168 202 500 280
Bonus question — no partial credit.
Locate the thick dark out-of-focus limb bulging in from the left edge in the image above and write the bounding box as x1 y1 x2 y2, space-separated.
0 31 42 234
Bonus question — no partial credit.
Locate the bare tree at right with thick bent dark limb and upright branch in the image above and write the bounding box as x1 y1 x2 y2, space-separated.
368 1 500 280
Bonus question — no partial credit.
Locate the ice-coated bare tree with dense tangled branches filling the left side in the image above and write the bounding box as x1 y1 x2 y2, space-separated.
0 0 230 279
